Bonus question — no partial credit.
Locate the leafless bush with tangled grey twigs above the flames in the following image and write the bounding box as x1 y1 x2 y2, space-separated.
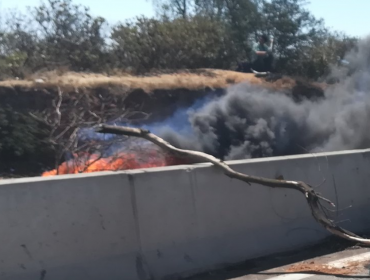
29 87 139 174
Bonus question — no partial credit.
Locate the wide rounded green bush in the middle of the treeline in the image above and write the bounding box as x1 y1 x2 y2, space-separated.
111 15 236 73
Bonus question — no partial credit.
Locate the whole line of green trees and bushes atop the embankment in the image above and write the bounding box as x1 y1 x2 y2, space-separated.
0 0 356 79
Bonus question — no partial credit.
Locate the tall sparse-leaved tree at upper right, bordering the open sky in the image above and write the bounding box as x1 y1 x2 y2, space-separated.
254 0 327 74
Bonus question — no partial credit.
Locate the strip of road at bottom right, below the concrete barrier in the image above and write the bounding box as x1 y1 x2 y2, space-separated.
189 247 370 280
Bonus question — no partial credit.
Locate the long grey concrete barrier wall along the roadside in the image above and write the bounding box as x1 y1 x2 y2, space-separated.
0 150 370 280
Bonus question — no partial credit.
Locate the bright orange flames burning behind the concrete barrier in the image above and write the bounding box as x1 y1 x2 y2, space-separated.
42 150 188 177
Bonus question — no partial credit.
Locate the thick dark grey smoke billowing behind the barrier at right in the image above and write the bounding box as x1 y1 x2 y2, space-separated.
156 37 370 159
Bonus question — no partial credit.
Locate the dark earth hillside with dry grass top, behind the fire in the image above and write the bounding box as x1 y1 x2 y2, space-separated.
0 69 324 177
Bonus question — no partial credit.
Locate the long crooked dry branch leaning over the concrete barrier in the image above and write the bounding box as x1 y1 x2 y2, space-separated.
96 125 370 245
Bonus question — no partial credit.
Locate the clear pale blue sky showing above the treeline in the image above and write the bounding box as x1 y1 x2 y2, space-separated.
0 0 370 37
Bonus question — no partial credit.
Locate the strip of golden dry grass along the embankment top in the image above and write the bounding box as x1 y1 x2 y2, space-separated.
0 69 302 92
